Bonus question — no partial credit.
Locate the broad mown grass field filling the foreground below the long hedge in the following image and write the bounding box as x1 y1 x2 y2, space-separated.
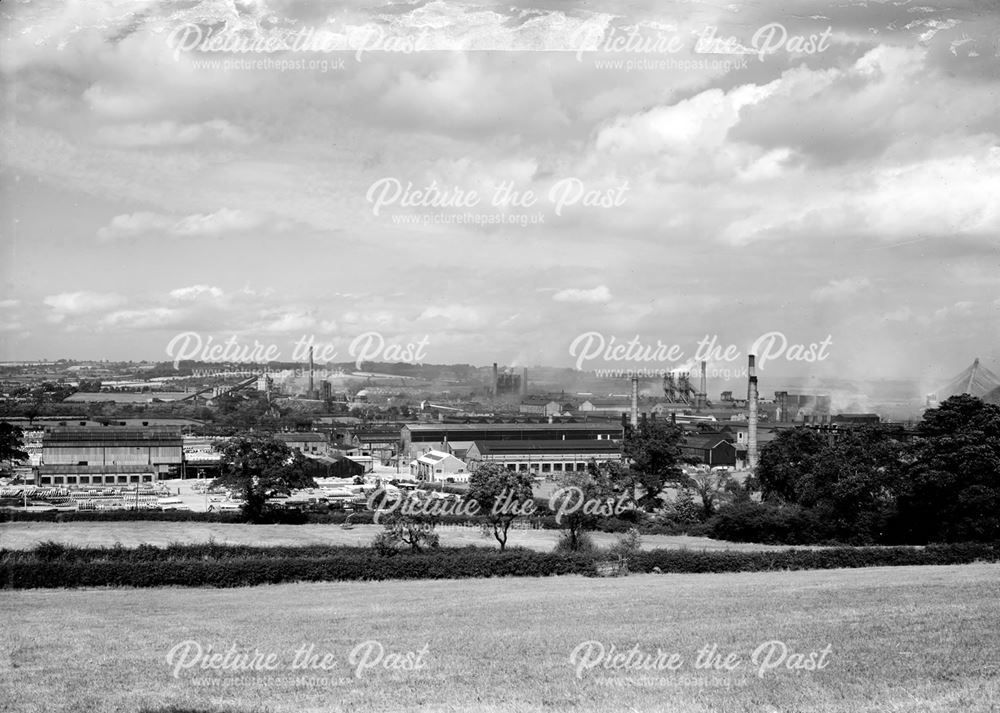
0 564 1000 713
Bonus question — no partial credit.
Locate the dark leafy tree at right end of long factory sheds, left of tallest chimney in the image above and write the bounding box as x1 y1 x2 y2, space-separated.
622 418 686 512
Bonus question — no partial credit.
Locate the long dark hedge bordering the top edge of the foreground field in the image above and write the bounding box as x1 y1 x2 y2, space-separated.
0 543 1000 589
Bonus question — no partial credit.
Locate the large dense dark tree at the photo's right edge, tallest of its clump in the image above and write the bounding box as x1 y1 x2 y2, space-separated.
899 394 1000 542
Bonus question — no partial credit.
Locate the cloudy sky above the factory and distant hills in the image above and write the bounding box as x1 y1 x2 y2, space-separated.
0 0 1000 379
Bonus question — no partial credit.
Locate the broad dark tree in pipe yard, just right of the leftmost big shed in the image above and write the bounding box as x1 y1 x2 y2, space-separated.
212 435 316 522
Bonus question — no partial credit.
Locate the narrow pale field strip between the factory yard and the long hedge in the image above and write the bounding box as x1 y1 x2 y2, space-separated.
0 521 804 551
